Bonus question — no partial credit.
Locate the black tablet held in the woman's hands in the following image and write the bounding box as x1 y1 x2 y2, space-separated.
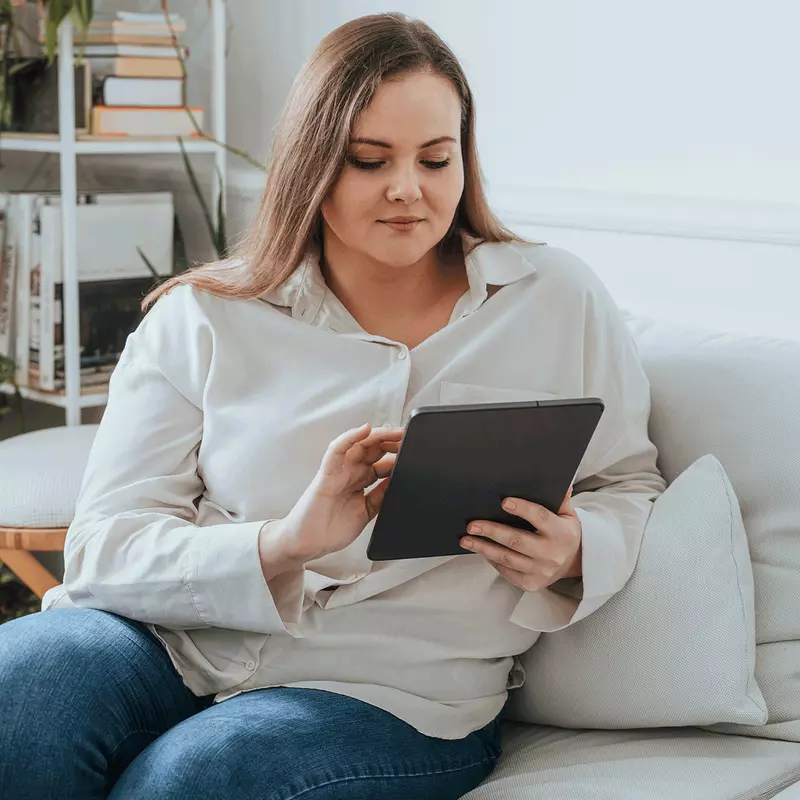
367 397 604 561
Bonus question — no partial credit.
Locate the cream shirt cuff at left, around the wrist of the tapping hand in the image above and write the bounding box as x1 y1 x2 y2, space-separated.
186 520 304 634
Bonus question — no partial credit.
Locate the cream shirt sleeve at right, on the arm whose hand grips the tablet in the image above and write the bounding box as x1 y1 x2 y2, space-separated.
511 268 666 633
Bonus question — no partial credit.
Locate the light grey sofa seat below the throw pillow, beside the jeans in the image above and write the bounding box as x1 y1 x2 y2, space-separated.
463 723 800 800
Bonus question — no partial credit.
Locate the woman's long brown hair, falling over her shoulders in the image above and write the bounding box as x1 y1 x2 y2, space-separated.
142 13 524 310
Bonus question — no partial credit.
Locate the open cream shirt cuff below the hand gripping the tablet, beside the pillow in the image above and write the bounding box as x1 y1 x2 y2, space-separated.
511 508 630 633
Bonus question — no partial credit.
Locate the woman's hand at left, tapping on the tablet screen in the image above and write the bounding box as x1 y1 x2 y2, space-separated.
259 423 405 579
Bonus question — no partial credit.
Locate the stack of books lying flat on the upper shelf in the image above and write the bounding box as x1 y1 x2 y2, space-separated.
84 11 203 137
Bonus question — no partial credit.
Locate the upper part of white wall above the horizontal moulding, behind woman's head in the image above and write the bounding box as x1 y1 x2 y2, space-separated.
223 0 800 202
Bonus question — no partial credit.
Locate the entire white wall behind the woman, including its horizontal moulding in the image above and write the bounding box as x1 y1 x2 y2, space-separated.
220 0 800 338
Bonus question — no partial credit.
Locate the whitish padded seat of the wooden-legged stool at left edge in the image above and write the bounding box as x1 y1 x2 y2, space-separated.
0 425 98 528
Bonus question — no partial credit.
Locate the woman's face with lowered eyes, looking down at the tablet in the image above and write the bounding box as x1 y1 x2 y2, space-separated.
322 73 464 267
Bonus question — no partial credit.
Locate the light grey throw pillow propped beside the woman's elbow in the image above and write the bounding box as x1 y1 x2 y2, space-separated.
506 455 767 728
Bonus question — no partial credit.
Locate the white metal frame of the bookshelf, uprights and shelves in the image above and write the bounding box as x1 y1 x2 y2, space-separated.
0 0 227 425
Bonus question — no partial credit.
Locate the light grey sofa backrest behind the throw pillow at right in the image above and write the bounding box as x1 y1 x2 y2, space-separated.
628 315 800 742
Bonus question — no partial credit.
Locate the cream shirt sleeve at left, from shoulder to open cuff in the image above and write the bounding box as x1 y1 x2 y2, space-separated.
63 287 302 633
